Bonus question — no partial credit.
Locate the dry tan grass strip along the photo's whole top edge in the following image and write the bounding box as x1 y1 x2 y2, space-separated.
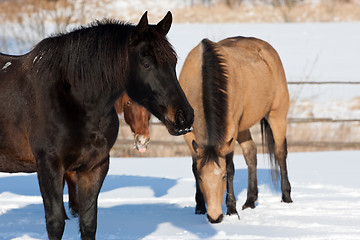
0 0 360 24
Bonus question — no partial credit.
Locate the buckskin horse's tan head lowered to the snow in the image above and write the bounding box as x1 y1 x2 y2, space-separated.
192 139 232 223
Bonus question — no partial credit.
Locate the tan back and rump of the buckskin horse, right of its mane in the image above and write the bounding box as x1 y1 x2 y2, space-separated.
218 37 289 130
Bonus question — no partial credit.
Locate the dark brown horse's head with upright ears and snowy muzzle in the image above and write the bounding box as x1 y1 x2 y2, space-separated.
126 12 194 135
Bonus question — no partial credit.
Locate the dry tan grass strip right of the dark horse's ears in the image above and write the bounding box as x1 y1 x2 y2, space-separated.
174 0 360 23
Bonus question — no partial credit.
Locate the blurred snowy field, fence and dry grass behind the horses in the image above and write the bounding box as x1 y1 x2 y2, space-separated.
0 0 360 157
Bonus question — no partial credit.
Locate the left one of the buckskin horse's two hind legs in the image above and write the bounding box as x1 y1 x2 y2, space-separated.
237 130 258 210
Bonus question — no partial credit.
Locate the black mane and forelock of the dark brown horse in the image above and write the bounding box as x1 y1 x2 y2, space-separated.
30 19 177 94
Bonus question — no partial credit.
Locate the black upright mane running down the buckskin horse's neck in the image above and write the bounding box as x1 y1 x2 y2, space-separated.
201 39 228 167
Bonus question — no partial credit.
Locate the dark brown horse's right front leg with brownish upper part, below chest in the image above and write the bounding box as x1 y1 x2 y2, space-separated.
77 156 109 239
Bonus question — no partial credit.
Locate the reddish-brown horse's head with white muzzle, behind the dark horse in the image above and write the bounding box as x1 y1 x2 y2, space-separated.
115 93 150 153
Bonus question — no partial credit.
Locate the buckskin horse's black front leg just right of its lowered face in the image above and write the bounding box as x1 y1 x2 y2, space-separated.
226 152 239 216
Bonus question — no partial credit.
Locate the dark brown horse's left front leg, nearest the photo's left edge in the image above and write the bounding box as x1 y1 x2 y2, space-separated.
37 151 67 240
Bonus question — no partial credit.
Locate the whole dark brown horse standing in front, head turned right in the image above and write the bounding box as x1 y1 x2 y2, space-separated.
0 12 194 239
